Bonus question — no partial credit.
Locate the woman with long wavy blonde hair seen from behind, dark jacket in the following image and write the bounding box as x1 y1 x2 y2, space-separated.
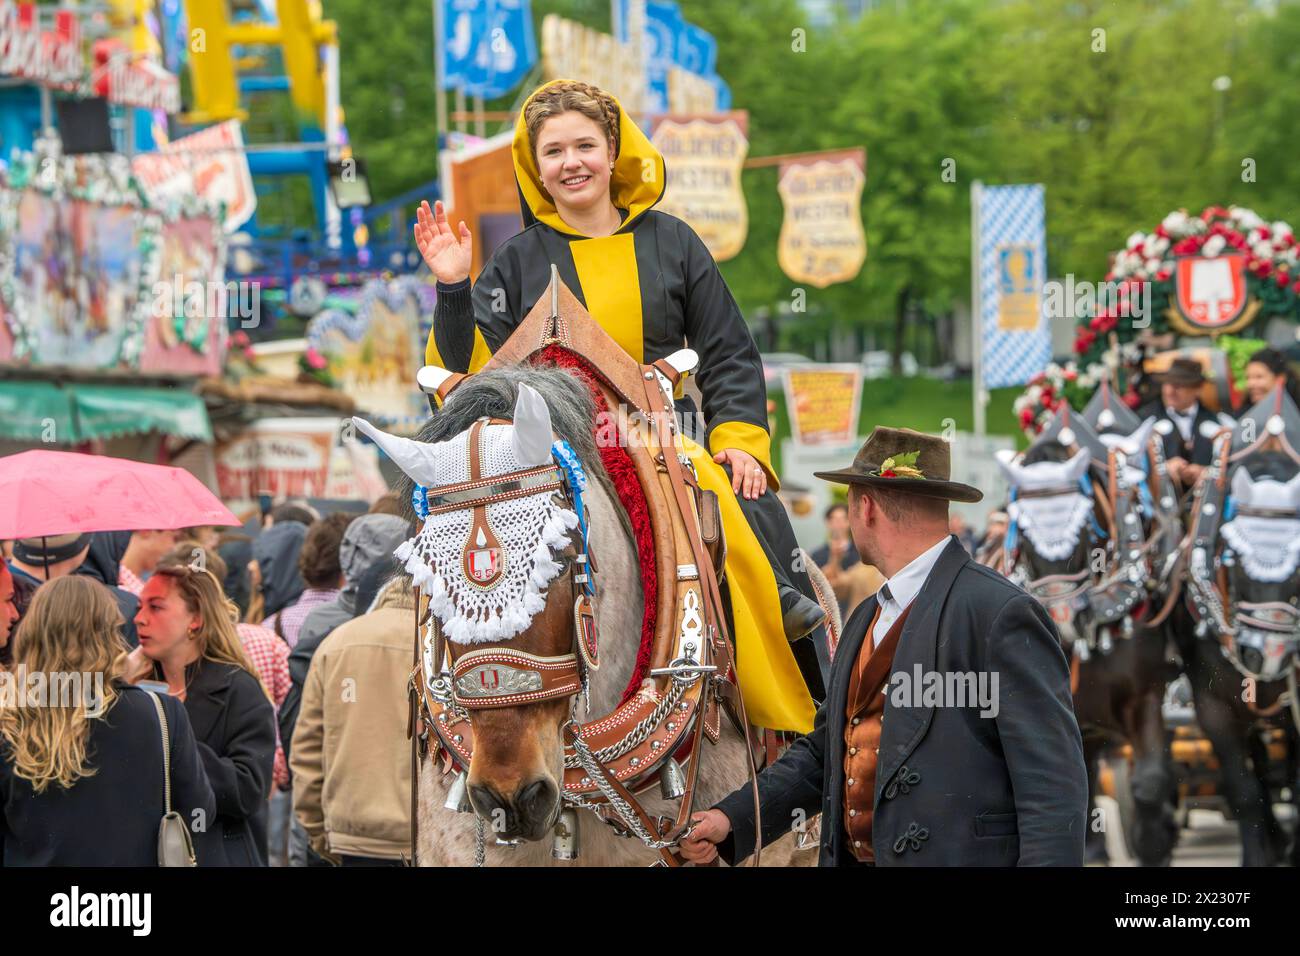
0 576 217 866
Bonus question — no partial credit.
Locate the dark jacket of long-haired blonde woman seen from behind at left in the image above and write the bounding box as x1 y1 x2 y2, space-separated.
0 684 217 866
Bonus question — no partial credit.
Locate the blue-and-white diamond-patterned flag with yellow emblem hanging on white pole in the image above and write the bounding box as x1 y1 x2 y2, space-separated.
971 185 1052 389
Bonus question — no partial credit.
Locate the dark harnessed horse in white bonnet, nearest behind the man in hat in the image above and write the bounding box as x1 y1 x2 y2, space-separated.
1000 419 1178 866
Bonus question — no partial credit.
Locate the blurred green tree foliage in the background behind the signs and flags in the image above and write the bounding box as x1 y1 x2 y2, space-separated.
324 0 1300 358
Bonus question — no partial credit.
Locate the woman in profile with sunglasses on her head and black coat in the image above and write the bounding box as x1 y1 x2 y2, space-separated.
130 564 276 866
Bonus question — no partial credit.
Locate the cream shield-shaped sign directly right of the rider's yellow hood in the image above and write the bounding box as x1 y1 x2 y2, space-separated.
650 112 749 261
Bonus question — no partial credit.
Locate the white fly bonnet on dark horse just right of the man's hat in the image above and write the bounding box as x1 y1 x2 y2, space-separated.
997 449 1092 561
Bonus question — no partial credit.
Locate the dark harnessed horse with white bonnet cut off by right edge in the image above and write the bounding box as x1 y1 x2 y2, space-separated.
1174 408 1300 866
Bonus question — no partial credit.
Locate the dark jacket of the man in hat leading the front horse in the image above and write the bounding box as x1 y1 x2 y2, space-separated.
718 538 1088 866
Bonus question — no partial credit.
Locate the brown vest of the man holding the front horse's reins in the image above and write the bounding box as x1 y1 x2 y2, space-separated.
844 605 911 862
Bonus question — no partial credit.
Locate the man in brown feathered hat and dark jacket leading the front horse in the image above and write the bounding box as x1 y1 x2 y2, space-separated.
681 428 1088 866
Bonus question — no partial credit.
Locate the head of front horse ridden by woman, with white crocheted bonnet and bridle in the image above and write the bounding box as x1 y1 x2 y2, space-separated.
359 368 598 840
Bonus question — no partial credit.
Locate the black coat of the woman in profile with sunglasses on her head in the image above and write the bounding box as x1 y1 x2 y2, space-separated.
162 661 276 866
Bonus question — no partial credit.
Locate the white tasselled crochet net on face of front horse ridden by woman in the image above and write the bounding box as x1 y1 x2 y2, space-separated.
394 425 577 644
